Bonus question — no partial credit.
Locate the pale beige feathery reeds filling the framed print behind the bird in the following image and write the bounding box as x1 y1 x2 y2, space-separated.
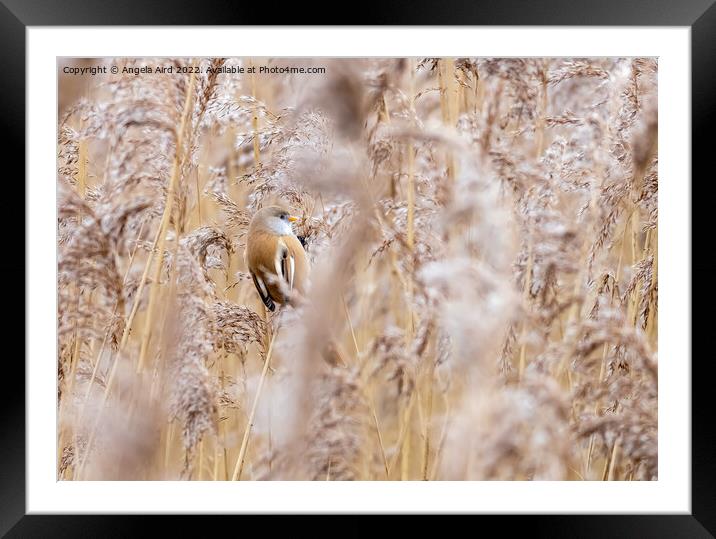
57 58 658 481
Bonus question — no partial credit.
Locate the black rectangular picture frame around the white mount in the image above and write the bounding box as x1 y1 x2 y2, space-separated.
0 0 716 537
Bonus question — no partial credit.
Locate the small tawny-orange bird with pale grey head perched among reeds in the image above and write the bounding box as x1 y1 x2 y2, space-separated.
244 206 309 311
